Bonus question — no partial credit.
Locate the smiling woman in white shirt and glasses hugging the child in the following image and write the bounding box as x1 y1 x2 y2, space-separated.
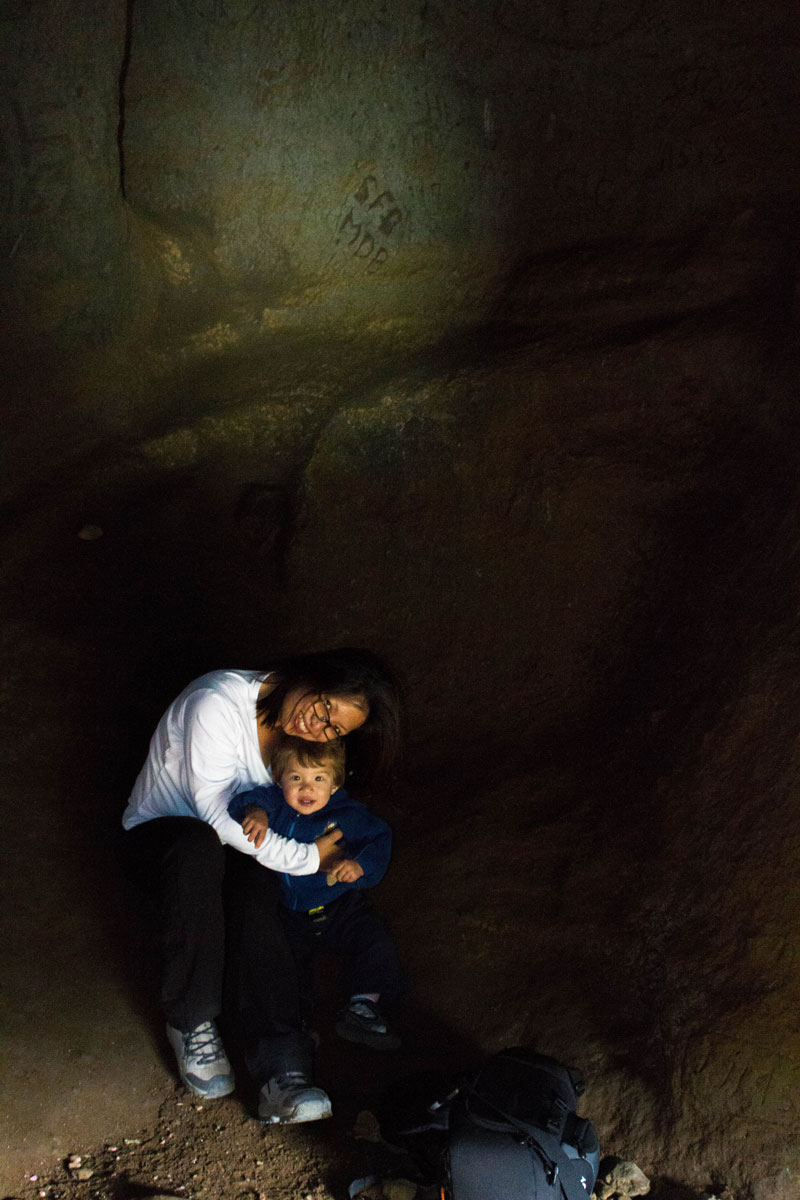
122 649 399 1123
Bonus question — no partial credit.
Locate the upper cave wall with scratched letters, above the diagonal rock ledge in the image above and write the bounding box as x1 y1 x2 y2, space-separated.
2 0 794 487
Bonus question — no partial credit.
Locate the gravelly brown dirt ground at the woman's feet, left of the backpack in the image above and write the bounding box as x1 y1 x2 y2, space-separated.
1 1027 676 1200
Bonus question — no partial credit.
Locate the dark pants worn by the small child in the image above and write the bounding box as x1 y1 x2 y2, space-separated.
281 890 405 1021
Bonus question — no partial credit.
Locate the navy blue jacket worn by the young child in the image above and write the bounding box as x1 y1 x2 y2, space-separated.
228 784 392 912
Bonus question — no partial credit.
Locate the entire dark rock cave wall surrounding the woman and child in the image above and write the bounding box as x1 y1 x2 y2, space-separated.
0 0 800 1200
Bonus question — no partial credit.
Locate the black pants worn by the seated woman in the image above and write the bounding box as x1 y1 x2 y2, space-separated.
122 817 313 1086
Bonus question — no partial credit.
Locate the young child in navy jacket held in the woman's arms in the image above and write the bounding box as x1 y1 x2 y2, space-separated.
228 738 403 1050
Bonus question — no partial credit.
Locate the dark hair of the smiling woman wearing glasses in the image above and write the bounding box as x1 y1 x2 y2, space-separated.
255 646 401 779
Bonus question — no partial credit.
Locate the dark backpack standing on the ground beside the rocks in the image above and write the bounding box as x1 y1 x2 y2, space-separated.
443 1046 600 1200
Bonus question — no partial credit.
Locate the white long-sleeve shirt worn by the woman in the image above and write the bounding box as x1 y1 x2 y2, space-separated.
122 671 319 875
